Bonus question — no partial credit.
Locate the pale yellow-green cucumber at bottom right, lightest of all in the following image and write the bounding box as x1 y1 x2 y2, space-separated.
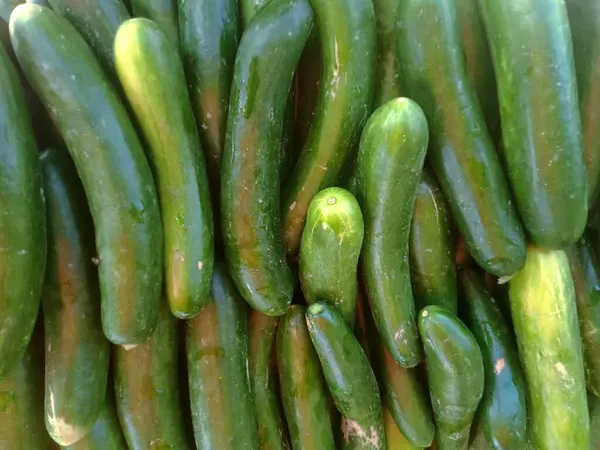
509 247 590 450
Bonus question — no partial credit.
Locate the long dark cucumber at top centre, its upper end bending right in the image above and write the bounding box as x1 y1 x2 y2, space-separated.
221 0 312 316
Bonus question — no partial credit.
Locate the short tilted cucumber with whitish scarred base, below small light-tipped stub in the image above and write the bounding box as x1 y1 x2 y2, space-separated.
306 302 386 449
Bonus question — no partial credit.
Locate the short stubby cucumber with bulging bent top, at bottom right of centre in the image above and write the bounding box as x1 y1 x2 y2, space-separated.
419 305 484 450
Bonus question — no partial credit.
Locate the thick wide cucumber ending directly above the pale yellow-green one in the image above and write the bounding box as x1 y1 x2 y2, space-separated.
479 0 588 248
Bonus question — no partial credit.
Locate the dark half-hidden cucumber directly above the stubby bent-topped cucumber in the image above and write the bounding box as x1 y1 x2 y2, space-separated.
409 170 457 312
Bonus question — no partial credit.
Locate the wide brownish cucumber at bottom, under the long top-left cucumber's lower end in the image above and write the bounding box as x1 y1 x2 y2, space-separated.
113 299 190 450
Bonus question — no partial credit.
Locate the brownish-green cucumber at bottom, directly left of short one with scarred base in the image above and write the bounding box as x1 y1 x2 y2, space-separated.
277 305 336 450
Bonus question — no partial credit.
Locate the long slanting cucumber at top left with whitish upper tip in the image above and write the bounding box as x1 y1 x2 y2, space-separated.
10 5 163 344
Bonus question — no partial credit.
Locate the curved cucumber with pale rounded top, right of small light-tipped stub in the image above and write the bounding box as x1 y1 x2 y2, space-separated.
356 98 429 367
